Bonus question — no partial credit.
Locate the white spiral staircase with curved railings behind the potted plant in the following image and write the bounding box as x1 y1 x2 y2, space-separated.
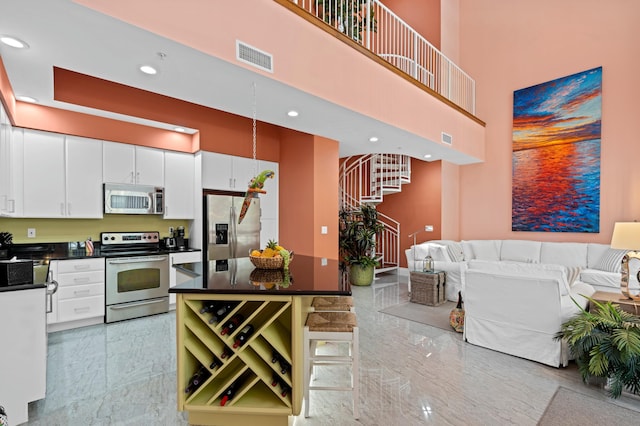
340 154 411 274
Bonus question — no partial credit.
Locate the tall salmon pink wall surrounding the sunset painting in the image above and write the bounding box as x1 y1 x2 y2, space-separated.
459 0 640 243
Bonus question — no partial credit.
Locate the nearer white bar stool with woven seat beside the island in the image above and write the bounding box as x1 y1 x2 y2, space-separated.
303 312 360 419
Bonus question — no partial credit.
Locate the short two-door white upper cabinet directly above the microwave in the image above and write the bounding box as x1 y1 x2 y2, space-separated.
103 142 164 186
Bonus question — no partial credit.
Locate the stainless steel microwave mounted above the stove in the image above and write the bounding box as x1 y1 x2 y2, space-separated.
104 183 164 214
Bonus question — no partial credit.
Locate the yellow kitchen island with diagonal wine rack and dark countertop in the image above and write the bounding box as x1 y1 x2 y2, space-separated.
170 255 351 425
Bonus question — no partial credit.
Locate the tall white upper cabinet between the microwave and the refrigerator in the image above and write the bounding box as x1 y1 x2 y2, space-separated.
164 151 195 219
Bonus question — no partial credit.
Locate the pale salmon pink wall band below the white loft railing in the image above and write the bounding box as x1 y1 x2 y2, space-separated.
77 0 484 159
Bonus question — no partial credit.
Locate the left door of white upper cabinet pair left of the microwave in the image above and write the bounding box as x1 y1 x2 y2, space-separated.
22 129 66 218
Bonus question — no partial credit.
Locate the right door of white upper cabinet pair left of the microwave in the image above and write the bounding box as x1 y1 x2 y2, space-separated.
65 136 103 218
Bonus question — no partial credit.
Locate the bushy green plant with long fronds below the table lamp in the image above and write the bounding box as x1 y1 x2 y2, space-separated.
556 298 640 398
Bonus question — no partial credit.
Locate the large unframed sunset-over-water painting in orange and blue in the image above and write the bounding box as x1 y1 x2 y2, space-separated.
511 67 602 232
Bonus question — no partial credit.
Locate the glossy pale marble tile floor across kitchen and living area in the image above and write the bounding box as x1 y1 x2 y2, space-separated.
23 274 640 426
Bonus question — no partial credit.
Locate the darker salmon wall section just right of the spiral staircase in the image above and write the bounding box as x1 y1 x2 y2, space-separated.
378 159 442 268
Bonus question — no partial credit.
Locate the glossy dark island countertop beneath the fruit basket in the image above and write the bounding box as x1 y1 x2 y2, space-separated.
169 255 351 296
